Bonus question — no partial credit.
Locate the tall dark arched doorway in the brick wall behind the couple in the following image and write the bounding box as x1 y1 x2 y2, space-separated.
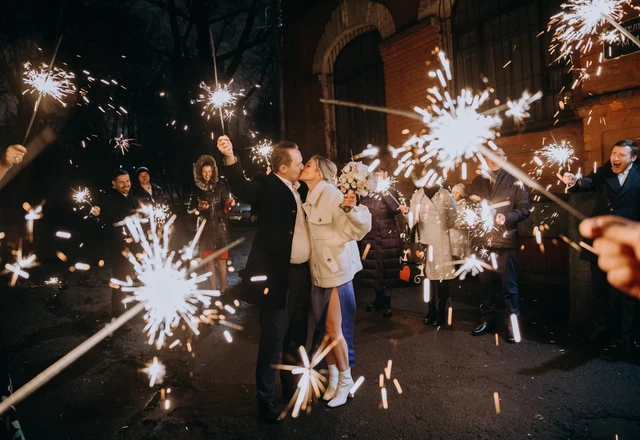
333 31 387 163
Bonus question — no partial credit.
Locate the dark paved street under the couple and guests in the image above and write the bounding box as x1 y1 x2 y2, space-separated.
0 227 640 440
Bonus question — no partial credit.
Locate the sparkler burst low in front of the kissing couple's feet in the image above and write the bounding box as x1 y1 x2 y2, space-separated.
272 336 340 419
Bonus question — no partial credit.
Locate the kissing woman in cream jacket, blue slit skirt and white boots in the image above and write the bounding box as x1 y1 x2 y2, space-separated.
300 156 371 408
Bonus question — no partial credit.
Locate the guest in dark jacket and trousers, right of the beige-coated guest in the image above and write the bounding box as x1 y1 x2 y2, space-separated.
469 148 530 343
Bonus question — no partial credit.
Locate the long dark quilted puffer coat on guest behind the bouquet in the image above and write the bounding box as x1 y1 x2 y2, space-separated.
359 193 402 292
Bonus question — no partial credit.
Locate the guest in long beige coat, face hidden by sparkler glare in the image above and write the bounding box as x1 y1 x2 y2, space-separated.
410 183 456 327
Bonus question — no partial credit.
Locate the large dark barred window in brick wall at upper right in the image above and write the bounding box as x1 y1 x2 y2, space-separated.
452 0 573 133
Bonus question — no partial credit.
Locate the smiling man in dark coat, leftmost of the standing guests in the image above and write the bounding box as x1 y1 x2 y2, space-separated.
91 169 140 318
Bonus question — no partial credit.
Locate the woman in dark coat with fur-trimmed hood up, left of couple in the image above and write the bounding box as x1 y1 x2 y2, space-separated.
188 155 235 294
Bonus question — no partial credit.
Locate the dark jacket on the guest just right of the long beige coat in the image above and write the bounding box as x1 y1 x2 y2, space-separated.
469 168 530 249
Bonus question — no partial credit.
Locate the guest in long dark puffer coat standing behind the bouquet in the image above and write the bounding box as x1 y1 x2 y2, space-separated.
359 170 407 318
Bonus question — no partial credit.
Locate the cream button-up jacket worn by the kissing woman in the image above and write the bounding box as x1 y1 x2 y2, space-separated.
302 182 371 288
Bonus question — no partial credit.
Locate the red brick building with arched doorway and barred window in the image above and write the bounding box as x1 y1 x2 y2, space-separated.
283 0 640 318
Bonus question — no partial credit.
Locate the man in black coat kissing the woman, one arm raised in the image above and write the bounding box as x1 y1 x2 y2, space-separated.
218 136 311 423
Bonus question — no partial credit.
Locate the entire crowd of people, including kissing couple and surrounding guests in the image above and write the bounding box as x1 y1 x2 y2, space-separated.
0 136 640 430
